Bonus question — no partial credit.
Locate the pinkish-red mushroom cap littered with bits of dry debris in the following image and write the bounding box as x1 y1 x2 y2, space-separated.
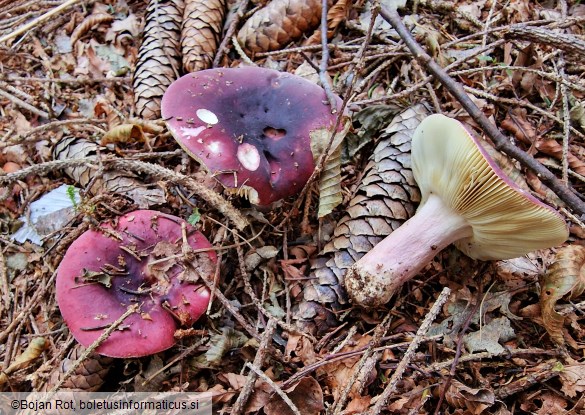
56 210 217 357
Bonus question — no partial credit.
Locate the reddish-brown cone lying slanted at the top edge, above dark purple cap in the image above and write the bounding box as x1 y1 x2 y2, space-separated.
238 0 321 53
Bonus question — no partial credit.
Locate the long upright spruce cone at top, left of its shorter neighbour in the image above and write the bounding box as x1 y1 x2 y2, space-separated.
132 0 184 120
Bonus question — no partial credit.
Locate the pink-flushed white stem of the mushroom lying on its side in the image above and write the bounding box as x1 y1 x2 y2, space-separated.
345 194 472 306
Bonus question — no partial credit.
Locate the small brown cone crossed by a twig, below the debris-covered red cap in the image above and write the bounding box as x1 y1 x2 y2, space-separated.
44 344 114 392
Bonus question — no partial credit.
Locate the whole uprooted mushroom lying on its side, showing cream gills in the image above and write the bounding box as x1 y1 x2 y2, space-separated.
345 114 569 307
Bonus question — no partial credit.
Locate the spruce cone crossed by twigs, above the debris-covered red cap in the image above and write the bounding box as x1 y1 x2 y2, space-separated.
53 137 166 209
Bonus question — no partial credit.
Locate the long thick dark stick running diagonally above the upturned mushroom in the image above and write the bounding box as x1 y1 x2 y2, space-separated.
380 7 585 215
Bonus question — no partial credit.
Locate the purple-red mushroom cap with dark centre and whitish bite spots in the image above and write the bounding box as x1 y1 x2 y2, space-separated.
161 67 343 205
